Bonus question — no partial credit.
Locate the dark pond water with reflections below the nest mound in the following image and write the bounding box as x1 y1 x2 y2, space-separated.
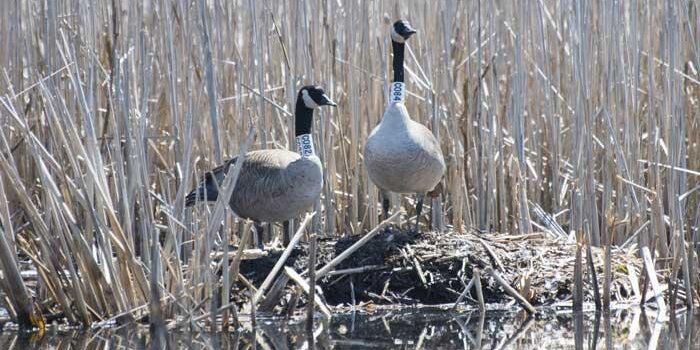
0 309 700 350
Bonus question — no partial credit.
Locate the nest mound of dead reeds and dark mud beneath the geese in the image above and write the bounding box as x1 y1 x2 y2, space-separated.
232 226 641 311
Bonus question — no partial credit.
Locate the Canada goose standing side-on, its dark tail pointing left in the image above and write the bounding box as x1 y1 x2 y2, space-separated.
185 85 336 248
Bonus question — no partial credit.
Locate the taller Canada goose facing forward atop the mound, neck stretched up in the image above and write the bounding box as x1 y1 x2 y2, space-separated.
364 20 445 230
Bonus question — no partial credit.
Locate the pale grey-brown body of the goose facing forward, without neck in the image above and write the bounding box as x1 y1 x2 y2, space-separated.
364 103 445 193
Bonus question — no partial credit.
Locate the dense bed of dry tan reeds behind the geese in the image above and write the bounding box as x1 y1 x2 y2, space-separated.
0 0 700 330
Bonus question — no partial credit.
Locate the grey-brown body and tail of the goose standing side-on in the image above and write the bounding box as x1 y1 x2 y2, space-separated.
186 150 323 222
